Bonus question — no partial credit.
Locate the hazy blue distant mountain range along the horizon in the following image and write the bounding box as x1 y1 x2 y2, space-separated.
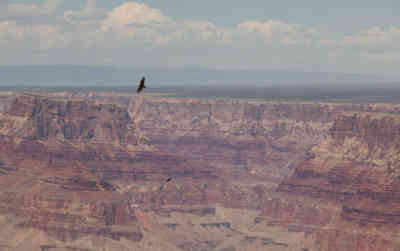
0 65 392 86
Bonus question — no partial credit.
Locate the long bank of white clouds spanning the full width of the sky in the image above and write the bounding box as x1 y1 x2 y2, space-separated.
0 0 400 74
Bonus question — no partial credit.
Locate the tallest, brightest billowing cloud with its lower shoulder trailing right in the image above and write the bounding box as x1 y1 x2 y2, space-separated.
101 2 233 47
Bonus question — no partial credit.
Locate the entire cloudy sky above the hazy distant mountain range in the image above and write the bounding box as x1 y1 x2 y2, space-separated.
0 0 400 77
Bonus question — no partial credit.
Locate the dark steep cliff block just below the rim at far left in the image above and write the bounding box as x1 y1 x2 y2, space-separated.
4 96 135 143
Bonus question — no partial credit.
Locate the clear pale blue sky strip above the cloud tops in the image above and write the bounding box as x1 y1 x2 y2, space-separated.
12 0 400 32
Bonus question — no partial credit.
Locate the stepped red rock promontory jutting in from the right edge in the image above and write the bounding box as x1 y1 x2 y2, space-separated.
278 113 400 250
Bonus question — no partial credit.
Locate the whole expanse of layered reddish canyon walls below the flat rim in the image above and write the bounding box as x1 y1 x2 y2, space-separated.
0 93 400 251
